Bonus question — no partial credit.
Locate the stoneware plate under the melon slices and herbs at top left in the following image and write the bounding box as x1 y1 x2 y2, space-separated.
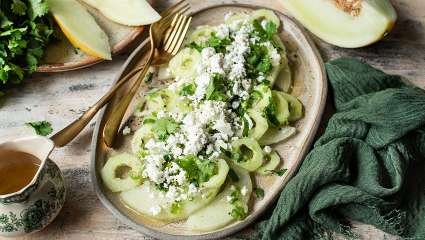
37 3 144 72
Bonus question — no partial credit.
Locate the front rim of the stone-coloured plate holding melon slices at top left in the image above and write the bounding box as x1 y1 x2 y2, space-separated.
37 26 145 73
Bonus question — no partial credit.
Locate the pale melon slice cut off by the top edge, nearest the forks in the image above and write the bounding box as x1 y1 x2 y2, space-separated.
83 0 161 26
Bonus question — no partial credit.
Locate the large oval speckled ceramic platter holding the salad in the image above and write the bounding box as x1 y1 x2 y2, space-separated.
91 4 327 239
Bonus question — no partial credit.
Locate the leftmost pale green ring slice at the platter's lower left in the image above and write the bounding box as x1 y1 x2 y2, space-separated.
100 153 143 192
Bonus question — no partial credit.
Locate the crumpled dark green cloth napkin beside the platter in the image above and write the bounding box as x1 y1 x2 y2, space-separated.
254 58 425 240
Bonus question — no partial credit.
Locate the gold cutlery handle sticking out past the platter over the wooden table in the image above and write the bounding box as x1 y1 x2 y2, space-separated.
50 63 142 147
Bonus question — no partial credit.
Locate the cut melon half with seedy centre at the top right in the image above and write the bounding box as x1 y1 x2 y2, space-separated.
281 0 397 48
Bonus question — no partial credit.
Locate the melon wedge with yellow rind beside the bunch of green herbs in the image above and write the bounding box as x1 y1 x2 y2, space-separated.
46 0 111 60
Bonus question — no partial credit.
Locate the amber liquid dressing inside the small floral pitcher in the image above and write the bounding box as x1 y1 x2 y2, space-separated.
0 150 41 195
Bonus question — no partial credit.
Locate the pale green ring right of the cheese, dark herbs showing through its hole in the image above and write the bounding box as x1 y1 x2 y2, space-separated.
232 138 264 172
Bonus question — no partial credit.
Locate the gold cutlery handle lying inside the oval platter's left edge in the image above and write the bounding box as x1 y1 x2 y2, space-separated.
103 51 154 147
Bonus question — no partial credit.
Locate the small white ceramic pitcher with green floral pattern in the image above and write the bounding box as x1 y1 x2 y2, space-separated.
0 137 65 237
